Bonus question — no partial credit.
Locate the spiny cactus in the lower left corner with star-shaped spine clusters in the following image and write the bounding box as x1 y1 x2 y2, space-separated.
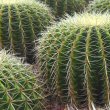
0 51 44 110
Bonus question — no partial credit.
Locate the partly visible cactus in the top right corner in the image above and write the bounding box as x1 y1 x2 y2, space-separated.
88 0 110 13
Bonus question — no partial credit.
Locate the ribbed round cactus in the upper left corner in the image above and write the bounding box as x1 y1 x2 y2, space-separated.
0 0 53 63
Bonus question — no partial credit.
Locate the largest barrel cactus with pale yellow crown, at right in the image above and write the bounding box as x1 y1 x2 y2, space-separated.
38 13 110 110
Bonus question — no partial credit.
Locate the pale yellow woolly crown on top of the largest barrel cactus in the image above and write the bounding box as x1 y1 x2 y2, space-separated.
71 13 110 27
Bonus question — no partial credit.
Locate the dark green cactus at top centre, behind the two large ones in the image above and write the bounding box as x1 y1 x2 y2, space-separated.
39 0 88 17
